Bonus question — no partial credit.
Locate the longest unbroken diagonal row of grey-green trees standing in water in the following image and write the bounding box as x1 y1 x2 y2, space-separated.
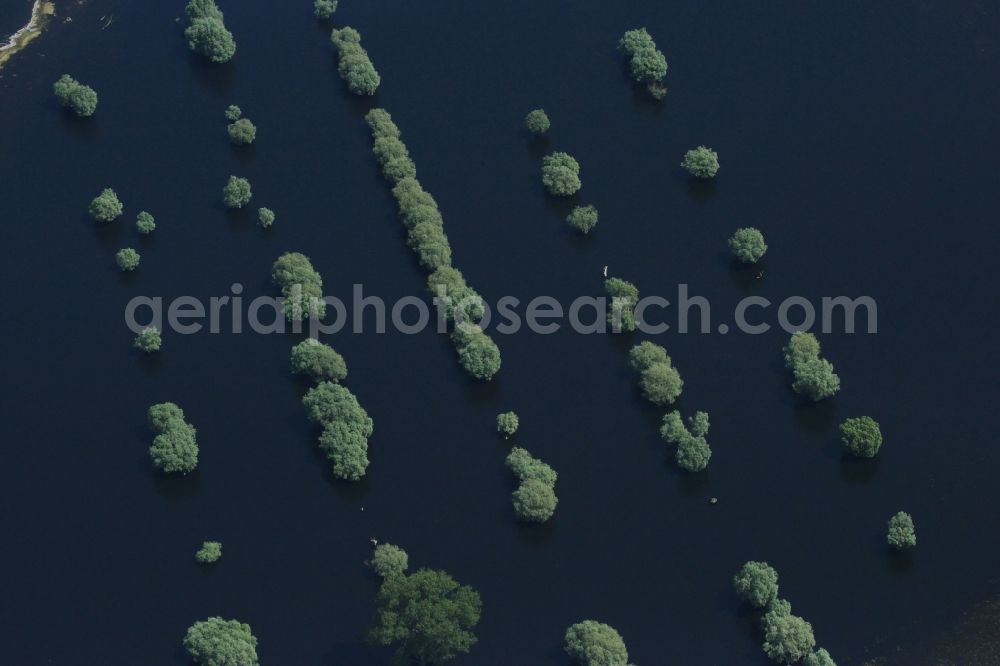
365 109 500 380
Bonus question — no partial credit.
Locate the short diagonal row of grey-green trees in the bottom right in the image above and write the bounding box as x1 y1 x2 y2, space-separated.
733 561 836 666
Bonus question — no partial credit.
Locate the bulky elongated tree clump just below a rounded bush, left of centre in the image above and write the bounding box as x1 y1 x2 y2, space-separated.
302 382 374 481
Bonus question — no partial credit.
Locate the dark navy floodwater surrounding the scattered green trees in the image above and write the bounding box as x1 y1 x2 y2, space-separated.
0 0 1000 666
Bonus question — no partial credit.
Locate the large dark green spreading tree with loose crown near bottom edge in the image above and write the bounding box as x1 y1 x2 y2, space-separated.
368 569 482 664
